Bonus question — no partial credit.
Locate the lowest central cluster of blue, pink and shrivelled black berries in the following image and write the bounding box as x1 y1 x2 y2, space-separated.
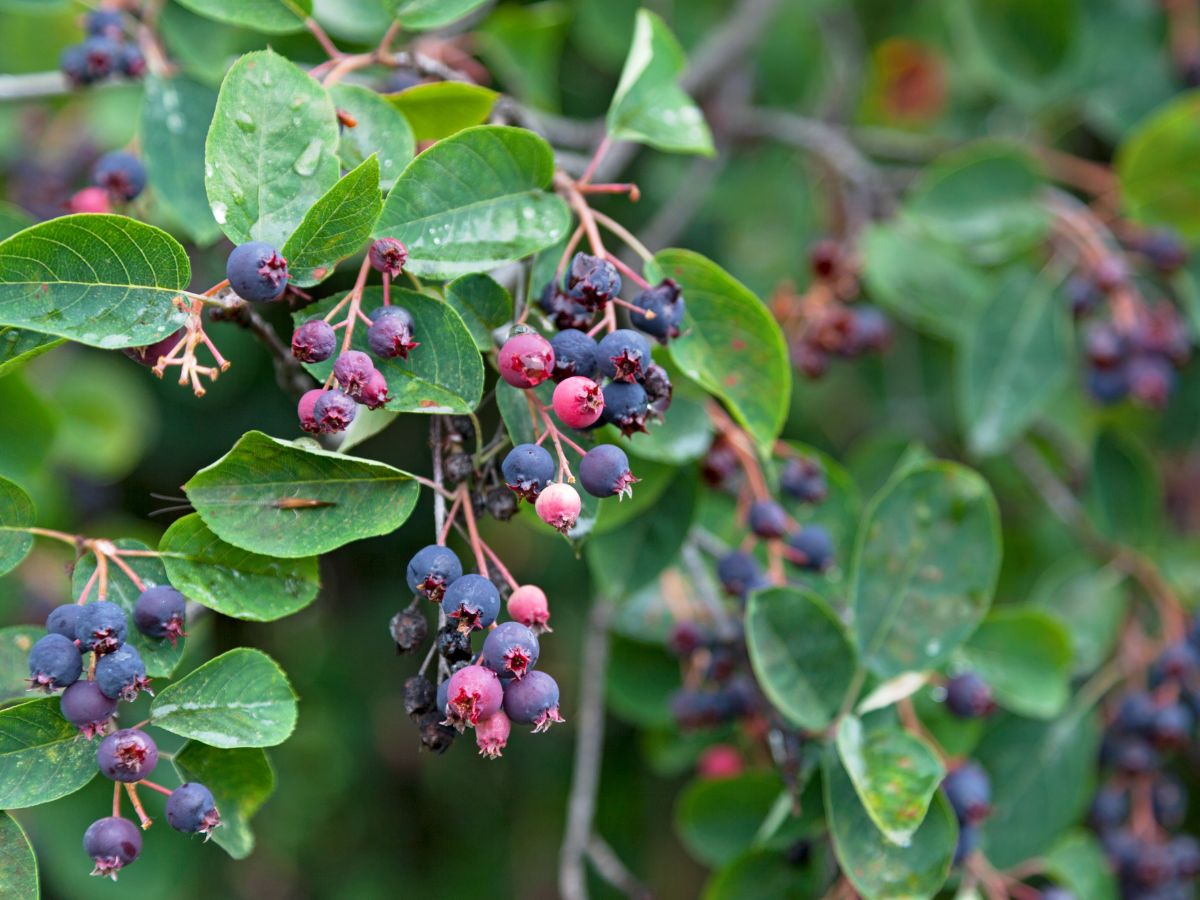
391 544 563 758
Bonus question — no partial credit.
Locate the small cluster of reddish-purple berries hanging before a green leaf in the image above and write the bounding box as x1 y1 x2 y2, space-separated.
292 238 420 434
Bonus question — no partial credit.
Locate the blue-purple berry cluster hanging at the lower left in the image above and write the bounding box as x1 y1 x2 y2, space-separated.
29 584 221 880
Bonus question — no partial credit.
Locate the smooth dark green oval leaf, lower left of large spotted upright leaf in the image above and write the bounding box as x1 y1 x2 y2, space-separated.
746 588 858 731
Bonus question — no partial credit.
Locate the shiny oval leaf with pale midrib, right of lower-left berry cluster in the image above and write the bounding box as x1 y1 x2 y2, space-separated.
150 647 296 748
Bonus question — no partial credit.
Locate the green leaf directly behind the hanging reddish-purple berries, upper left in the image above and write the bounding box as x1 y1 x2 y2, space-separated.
293 287 482 415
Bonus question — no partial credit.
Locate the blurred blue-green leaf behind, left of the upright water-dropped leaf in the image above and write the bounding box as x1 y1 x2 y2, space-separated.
139 74 221 245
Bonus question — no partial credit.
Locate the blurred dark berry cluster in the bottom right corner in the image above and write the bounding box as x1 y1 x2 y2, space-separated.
1090 626 1200 900
